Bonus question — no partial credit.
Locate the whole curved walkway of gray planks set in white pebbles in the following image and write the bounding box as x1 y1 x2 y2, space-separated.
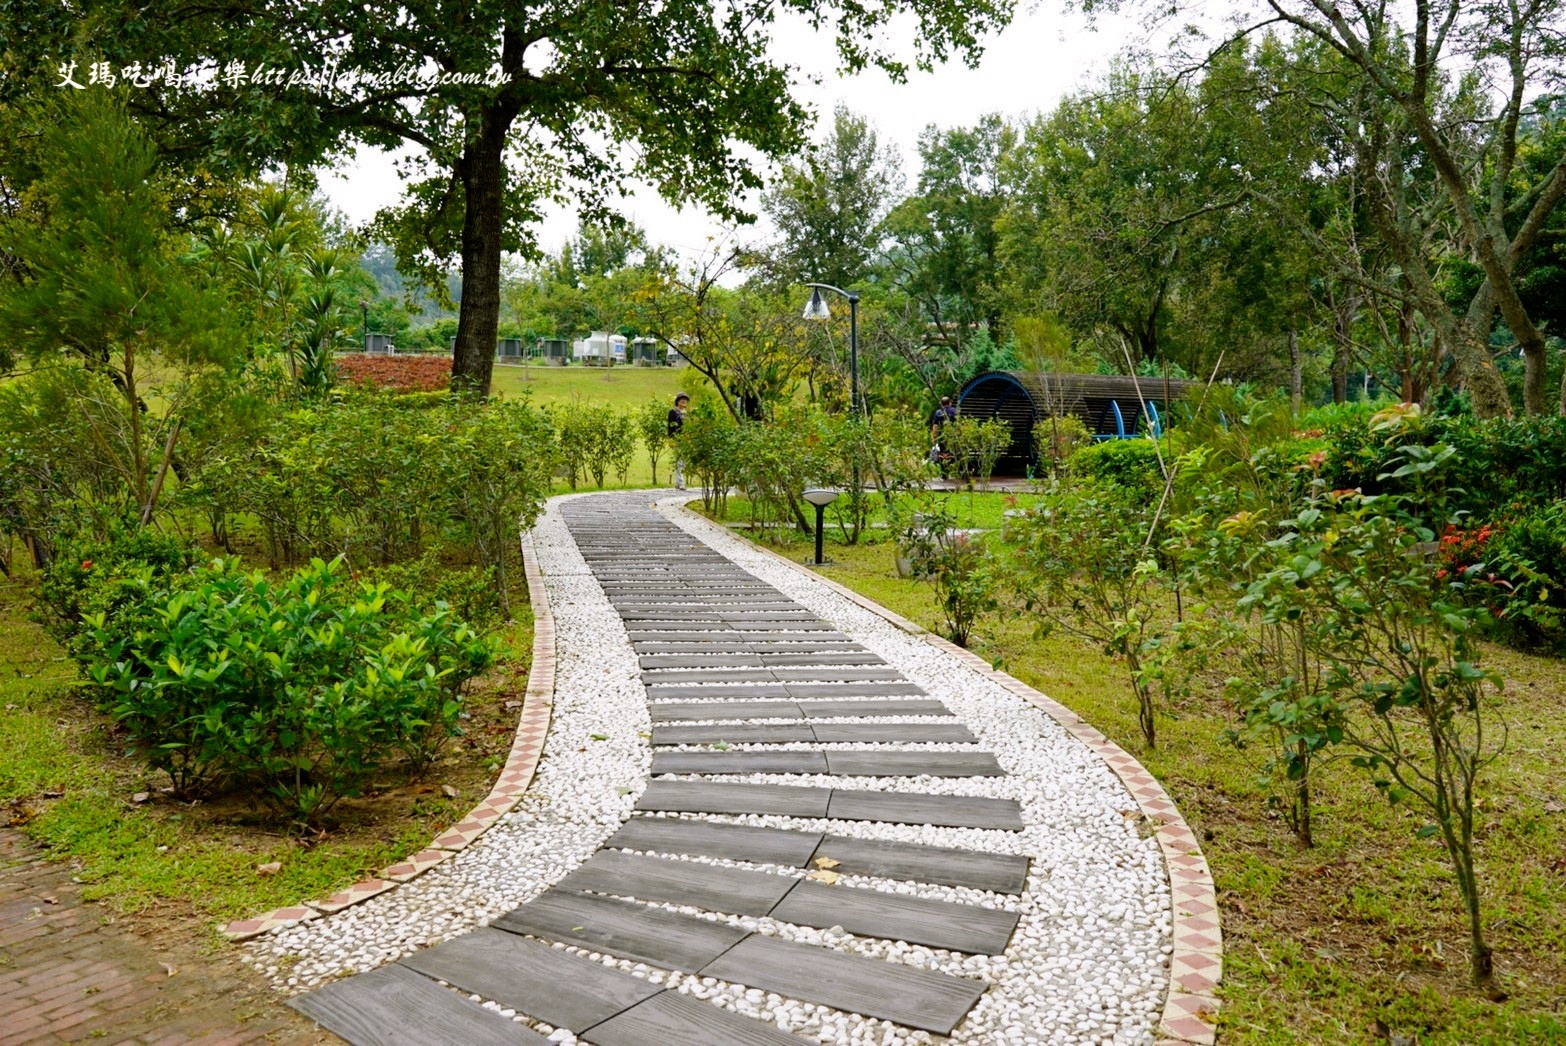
266 493 1215 1046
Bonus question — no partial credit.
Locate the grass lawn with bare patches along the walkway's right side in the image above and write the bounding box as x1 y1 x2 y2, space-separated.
704 495 1566 1046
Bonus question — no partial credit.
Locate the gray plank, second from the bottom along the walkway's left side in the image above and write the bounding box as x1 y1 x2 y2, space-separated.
402 930 659 1032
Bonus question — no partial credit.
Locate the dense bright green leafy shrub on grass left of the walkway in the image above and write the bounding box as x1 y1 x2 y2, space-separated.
86 559 493 824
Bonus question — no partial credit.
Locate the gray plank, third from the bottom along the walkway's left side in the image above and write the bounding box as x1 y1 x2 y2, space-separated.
490 886 745 972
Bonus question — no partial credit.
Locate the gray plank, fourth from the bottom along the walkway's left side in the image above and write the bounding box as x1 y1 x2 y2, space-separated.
556 850 795 925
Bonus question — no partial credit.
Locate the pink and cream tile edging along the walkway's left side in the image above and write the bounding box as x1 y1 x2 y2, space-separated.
222 532 554 941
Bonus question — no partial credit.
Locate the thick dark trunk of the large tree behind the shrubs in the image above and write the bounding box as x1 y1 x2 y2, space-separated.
451 114 506 396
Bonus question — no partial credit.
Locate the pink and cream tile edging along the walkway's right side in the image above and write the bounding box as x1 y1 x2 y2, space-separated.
669 496 1223 1046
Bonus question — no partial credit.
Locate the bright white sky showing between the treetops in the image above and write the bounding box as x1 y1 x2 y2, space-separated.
321 0 1138 266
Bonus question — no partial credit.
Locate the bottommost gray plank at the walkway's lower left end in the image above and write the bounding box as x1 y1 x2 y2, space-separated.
288 963 550 1046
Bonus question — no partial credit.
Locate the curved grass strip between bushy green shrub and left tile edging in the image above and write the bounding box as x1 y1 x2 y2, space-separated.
0 566 532 940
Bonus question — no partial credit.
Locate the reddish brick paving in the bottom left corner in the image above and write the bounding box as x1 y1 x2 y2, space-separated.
0 828 321 1046
